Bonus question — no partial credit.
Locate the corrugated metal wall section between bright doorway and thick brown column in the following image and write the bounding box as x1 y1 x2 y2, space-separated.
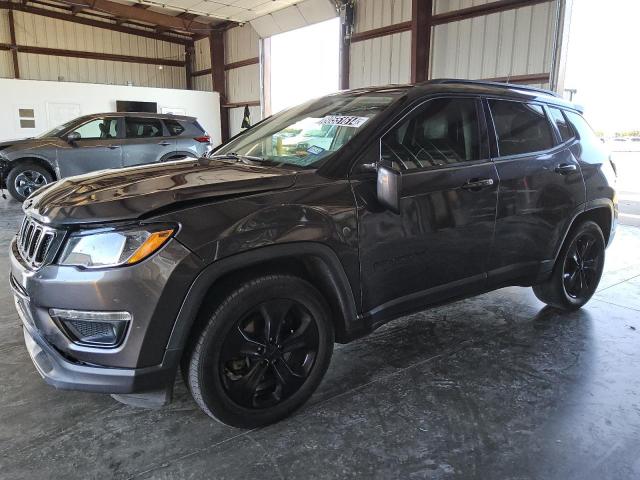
349 0 411 88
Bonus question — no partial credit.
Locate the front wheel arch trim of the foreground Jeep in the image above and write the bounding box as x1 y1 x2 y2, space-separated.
167 242 364 350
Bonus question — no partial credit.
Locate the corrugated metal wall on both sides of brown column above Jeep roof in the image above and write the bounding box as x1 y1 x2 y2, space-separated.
349 0 562 88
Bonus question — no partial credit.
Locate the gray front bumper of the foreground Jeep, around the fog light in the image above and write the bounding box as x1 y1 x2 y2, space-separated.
10 232 202 394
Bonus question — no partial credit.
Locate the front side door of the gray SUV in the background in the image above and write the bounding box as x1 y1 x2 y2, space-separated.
58 117 122 178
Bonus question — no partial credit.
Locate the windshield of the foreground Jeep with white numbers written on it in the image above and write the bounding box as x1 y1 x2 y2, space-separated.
215 89 404 168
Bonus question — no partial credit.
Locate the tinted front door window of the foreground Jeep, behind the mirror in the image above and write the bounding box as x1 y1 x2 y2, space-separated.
382 98 480 169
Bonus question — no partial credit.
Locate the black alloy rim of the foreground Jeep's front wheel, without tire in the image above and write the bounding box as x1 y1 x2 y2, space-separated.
219 298 320 409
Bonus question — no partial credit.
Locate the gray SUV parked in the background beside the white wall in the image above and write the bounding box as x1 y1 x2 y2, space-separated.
0 113 210 201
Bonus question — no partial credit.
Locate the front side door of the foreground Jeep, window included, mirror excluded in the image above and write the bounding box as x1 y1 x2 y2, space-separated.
353 97 498 324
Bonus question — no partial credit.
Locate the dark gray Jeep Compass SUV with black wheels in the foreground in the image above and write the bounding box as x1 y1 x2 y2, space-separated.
11 80 618 427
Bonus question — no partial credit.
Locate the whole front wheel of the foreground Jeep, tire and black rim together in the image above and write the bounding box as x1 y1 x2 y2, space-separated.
186 275 334 428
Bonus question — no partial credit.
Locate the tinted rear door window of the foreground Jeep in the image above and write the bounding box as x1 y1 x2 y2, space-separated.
489 100 554 156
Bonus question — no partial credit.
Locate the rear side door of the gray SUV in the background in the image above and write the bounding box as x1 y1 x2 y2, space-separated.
122 117 176 167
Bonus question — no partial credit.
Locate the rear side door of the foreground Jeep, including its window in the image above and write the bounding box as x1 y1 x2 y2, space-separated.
485 99 585 285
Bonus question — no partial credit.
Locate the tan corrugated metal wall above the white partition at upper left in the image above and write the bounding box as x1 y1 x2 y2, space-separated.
0 10 186 88
